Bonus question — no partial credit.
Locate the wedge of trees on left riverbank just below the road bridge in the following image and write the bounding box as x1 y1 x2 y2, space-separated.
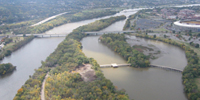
0 36 34 60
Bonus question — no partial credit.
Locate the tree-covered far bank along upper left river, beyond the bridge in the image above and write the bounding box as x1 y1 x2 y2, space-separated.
14 10 117 34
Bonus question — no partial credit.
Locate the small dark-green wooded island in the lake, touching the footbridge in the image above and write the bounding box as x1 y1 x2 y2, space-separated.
100 34 150 67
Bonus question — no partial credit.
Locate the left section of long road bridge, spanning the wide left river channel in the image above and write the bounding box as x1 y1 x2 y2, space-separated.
10 34 68 38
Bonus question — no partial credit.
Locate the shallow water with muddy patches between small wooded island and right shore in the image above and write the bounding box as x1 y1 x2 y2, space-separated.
127 36 187 70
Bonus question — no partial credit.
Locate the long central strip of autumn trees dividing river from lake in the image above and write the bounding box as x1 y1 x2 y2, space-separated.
14 16 129 100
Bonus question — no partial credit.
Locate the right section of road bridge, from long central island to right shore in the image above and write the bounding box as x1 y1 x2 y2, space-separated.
83 31 135 35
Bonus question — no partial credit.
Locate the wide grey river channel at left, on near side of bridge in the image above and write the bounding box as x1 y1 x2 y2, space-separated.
0 38 64 100
